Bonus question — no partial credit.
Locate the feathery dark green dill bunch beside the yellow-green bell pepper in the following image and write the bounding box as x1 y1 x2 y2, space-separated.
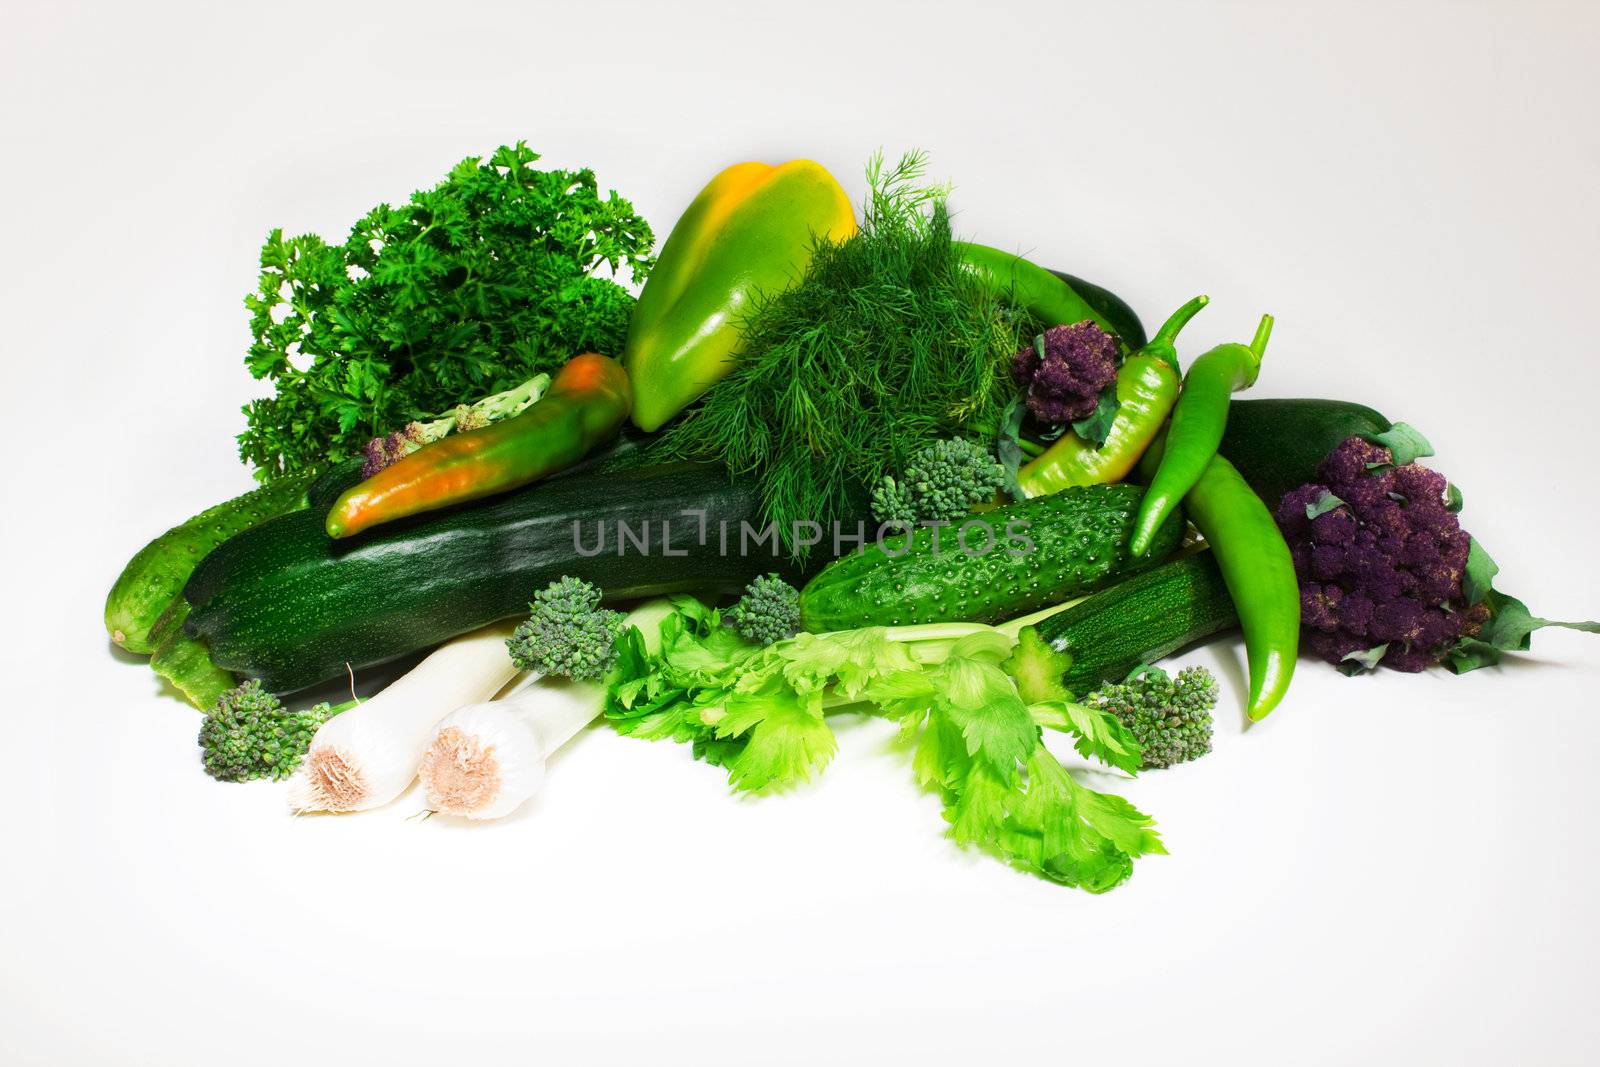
658 152 1021 557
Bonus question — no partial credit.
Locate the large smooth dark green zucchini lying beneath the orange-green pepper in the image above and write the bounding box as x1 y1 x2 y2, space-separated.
184 464 866 693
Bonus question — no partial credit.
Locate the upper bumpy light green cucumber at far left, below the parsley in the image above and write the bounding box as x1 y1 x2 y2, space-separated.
106 475 312 654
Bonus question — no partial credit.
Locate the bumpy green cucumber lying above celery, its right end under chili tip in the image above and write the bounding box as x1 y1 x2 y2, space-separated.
800 485 1182 633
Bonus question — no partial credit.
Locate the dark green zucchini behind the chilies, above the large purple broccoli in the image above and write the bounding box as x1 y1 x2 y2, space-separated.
1222 400 1390 511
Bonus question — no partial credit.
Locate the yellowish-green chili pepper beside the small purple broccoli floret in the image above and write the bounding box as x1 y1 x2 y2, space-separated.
1016 296 1210 496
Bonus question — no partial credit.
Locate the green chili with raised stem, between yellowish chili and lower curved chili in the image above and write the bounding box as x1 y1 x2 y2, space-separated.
1130 315 1272 557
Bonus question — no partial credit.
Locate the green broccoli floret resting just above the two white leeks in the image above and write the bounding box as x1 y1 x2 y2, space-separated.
506 576 622 681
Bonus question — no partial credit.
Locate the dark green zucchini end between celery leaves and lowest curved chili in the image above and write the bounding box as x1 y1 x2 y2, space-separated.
1032 552 1238 699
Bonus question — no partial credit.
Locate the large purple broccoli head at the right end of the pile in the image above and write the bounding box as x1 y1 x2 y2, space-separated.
1277 437 1488 672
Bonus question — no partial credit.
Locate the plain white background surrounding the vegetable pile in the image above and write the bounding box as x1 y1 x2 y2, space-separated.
0 0 1600 1067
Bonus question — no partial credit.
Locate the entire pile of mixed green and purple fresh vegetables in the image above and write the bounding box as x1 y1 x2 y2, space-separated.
106 144 1600 893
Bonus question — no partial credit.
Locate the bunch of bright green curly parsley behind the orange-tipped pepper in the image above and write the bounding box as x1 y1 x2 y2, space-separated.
238 141 654 482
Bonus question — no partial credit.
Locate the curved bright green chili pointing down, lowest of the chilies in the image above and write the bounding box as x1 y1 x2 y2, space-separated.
1139 440 1299 720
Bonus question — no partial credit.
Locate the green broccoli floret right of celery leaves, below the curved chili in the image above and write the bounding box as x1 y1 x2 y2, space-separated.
1083 667 1216 768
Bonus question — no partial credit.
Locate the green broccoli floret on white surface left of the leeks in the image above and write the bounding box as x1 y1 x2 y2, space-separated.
200 678 354 782
